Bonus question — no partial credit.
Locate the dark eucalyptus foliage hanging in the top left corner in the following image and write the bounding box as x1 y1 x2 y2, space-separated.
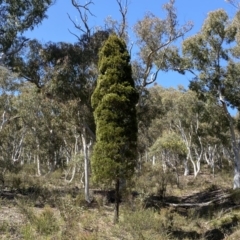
0 0 54 65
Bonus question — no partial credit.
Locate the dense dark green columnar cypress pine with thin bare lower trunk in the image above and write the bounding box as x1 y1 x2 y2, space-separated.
91 35 138 222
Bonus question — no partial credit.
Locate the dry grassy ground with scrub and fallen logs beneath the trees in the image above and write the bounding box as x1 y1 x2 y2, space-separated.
0 165 240 240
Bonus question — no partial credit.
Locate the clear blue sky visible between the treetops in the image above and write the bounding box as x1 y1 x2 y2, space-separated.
27 0 236 87
